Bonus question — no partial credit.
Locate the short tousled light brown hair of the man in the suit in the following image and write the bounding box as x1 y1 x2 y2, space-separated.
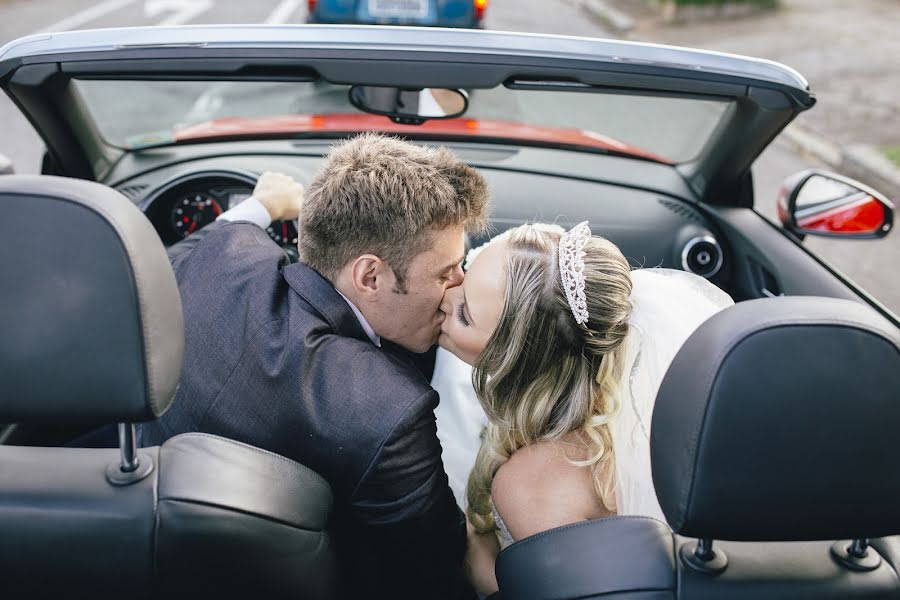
298 133 488 292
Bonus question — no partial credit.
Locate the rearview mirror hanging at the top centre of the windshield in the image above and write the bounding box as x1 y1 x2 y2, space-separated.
350 85 469 125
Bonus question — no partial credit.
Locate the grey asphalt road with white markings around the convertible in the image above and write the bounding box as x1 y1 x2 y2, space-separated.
0 0 900 313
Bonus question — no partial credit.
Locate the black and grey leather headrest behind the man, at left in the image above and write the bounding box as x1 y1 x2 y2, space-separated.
0 175 184 424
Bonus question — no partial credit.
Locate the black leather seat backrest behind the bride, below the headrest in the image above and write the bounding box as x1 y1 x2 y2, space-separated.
496 516 900 600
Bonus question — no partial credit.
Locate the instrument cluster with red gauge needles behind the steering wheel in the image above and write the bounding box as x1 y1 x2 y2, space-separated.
142 170 297 253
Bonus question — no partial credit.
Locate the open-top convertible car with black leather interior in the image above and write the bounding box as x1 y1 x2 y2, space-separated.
0 24 900 600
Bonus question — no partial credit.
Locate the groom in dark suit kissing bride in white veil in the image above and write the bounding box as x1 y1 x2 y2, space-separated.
141 134 731 598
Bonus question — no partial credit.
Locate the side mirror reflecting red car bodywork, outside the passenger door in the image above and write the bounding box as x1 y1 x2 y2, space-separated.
777 169 894 239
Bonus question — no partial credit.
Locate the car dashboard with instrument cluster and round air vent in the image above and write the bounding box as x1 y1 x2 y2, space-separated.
113 140 733 290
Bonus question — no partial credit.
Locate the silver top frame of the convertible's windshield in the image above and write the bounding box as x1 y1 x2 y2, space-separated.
0 25 809 89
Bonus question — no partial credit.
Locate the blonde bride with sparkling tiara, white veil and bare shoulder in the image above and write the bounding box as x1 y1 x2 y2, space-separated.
432 222 733 595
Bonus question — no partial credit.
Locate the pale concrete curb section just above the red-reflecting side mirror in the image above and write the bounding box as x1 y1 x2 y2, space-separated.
781 124 900 200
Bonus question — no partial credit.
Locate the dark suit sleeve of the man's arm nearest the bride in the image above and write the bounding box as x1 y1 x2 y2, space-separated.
352 390 474 599
